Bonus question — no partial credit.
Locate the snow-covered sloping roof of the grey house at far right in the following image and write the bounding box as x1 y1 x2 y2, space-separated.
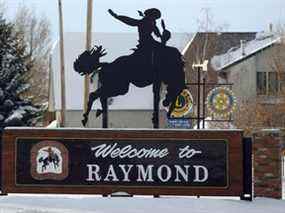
211 32 281 71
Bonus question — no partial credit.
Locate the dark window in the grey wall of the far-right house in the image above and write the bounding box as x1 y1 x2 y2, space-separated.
256 72 279 95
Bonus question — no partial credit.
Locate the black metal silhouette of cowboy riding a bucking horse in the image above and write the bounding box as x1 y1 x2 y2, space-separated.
74 8 185 126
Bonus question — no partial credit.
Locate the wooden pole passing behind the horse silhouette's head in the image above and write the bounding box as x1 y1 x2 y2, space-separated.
83 0 93 127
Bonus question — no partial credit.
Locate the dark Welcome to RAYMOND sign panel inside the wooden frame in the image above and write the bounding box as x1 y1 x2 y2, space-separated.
16 138 228 187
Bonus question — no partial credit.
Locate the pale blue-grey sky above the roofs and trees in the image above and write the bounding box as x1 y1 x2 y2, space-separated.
3 0 285 37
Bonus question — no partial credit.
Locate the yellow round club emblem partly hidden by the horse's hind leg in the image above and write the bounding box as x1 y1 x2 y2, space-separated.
171 89 193 118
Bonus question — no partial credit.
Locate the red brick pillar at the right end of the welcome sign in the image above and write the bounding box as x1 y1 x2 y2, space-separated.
253 130 282 199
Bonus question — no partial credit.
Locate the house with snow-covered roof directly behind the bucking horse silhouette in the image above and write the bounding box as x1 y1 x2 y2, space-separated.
48 32 191 128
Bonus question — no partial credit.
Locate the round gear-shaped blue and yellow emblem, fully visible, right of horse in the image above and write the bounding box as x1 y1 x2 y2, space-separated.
207 87 236 117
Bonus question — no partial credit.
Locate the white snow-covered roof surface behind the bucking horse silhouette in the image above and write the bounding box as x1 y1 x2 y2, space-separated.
51 32 191 110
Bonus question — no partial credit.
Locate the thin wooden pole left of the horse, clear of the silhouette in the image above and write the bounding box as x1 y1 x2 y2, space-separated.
58 0 66 127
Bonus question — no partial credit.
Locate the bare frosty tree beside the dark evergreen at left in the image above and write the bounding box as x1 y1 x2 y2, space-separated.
14 5 51 103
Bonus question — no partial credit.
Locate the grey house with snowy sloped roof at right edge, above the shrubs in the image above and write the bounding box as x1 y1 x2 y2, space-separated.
211 32 285 103
